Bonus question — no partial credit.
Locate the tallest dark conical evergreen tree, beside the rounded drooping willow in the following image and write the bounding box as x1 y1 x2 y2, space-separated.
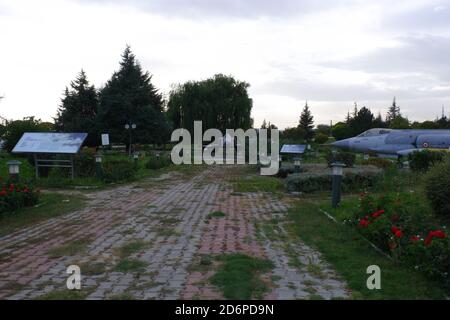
98 46 170 146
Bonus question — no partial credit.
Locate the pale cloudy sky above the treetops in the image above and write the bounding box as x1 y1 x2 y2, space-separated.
0 0 450 128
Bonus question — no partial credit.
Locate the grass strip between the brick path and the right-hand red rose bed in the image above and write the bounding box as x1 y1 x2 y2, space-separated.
288 200 445 299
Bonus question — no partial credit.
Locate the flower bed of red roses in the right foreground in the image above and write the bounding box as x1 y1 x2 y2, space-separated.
351 193 450 288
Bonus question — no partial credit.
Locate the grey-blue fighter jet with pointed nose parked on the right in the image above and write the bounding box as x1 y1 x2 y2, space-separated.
331 129 450 157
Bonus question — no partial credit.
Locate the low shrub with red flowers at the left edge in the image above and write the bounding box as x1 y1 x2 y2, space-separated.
0 183 39 213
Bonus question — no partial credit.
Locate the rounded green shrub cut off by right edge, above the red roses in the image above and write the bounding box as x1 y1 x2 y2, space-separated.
425 159 450 218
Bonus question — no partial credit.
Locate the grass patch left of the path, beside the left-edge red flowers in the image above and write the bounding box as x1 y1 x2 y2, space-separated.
0 193 84 236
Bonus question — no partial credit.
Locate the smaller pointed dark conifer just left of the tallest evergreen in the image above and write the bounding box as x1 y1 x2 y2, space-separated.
55 70 99 146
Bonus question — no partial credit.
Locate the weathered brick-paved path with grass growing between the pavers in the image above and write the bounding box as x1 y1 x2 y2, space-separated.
0 166 349 299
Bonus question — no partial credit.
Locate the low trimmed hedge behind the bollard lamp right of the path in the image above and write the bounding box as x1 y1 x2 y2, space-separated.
286 172 379 193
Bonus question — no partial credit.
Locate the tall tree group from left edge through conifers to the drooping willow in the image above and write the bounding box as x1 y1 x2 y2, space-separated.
0 46 253 151
